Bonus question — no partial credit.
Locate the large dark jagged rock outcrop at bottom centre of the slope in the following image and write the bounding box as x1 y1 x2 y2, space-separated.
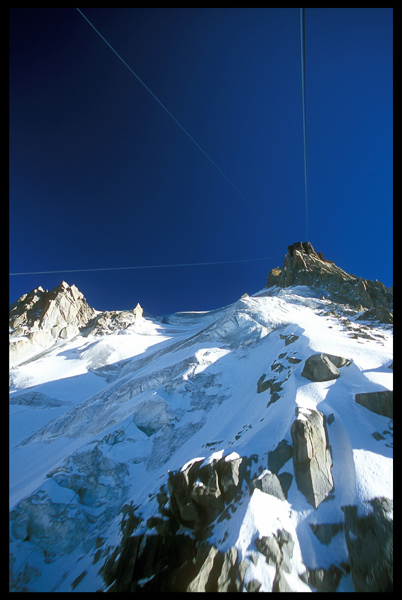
102 455 302 592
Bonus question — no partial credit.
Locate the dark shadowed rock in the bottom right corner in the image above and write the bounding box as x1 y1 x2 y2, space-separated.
342 498 393 592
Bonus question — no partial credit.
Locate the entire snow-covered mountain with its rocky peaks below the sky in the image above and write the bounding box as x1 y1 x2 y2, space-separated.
9 247 393 592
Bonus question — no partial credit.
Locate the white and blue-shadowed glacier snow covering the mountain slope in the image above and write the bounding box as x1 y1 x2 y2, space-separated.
9 286 393 592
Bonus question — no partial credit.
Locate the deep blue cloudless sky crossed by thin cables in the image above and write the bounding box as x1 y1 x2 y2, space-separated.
9 8 393 314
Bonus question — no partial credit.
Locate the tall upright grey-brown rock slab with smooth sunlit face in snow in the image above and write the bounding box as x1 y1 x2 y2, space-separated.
291 408 334 508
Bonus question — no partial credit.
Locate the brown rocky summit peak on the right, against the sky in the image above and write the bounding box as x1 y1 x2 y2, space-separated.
266 242 393 320
